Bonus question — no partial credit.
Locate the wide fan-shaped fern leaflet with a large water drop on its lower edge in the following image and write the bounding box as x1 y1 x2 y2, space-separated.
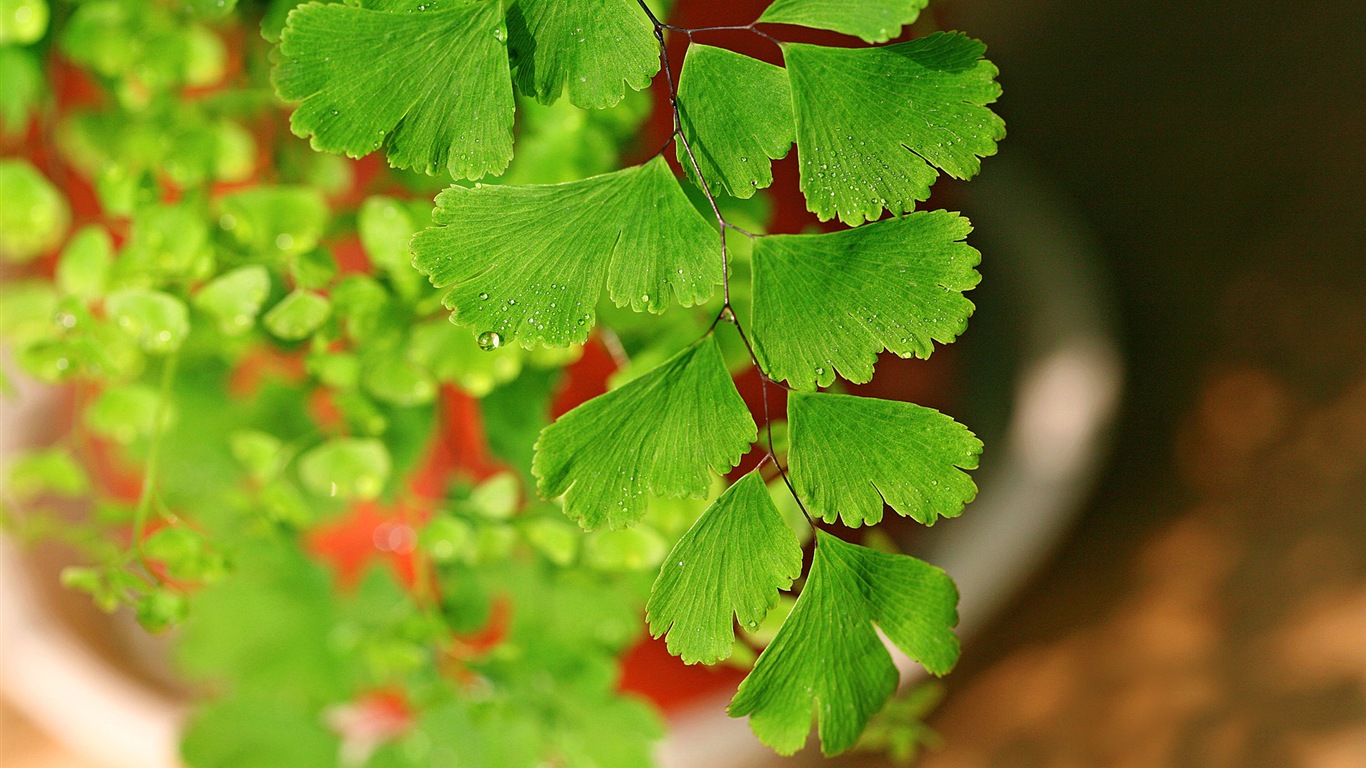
413 157 721 347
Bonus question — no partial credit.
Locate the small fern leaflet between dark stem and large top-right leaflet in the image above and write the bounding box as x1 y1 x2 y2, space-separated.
676 44 796 198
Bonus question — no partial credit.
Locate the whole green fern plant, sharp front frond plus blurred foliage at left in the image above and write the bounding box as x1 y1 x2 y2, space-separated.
0 0 1004 768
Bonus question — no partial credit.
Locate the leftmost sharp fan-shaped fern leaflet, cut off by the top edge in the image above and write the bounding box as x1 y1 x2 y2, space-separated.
275 0 514 179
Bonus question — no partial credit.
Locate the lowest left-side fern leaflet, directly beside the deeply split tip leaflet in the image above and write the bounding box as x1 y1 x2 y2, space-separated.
646 471 802 664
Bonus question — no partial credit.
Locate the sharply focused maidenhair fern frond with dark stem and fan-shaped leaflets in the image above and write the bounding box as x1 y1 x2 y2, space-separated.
277 0 1003 753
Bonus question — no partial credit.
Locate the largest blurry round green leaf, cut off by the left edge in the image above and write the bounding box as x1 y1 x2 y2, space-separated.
0 157 71 262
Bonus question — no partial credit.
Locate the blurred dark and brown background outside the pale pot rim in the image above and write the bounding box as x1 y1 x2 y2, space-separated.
0 0 1366 768
